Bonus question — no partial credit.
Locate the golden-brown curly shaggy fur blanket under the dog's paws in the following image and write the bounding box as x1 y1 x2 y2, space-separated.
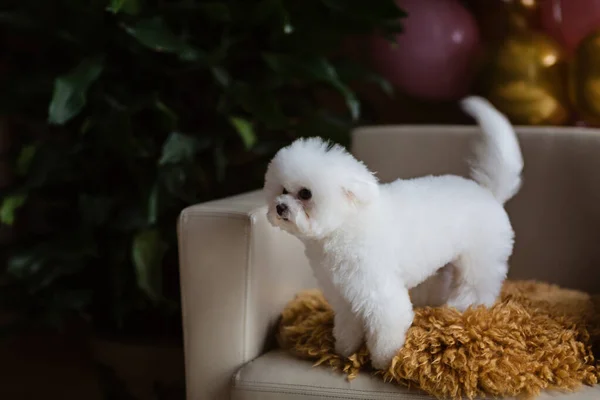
278 281 600 399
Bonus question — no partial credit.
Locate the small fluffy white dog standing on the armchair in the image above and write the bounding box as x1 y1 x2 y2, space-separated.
264 97 523 369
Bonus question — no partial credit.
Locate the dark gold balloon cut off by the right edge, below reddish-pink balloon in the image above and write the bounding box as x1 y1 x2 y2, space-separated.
569 32 600 126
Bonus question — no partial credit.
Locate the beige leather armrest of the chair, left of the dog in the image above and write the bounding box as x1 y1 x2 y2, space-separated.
178 192 315 400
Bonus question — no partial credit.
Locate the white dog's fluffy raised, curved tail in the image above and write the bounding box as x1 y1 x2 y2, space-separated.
461 96 523 204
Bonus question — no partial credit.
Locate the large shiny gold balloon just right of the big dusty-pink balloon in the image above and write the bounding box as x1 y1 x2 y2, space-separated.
483 30 569 125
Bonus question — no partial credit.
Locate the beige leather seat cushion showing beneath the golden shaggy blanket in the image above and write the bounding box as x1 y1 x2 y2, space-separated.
231 350 600 400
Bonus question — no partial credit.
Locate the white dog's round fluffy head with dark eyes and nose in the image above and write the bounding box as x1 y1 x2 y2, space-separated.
264 138 379 239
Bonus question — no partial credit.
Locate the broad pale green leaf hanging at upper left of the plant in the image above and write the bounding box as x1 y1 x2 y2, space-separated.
48 56 104 125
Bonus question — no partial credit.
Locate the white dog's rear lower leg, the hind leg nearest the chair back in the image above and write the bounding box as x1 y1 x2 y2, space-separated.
447 253 508 312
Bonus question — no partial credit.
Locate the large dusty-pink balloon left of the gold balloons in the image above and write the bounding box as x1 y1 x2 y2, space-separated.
372 0 480 100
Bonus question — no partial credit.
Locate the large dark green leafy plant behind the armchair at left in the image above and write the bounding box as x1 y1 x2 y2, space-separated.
0 0 404 335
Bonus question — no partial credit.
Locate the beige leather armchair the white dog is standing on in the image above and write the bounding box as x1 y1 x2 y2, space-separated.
179 126 600 400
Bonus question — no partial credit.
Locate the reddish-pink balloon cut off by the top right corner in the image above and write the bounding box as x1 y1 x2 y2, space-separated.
540 0 600 52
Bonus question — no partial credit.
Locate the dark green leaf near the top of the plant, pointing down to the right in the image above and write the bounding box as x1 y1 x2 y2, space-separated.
125 17 206 61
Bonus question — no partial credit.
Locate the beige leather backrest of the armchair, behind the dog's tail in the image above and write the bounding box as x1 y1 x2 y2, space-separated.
352 126 600 292
